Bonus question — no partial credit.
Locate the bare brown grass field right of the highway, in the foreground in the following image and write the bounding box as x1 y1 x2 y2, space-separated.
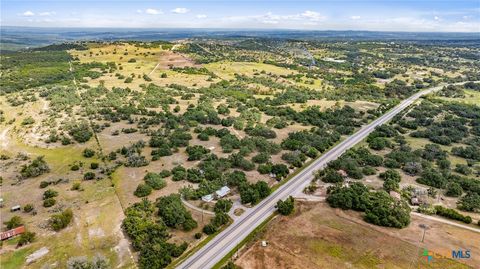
235 202 480 268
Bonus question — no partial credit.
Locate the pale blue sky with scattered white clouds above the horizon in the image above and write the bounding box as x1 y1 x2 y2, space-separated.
0 0 480 32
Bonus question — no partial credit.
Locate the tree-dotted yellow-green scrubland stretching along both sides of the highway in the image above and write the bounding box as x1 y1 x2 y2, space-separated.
0 33 480 269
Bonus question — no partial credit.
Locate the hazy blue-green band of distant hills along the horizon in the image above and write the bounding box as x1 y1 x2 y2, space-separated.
0 26 480 51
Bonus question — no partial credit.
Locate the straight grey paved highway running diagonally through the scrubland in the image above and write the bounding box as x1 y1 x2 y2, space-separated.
177 83 468 269
